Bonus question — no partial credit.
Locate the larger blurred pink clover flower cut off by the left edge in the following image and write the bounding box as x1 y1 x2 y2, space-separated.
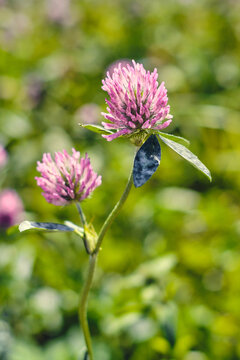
0 189 23 229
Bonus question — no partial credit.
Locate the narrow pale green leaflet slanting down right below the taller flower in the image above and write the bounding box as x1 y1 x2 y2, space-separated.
158 135 212 181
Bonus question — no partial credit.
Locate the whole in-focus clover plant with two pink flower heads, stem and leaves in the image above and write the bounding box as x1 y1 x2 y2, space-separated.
19 61 211 360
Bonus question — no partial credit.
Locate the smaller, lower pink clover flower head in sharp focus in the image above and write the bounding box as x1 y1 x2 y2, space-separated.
35 149 102 205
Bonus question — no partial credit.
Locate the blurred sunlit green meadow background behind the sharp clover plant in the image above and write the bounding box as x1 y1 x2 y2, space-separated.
0 0 240 360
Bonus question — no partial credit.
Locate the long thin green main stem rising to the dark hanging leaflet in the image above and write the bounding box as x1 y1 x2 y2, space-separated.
78 172 133 360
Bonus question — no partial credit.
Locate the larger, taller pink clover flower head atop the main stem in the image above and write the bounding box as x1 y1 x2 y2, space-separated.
102 60 172 145
